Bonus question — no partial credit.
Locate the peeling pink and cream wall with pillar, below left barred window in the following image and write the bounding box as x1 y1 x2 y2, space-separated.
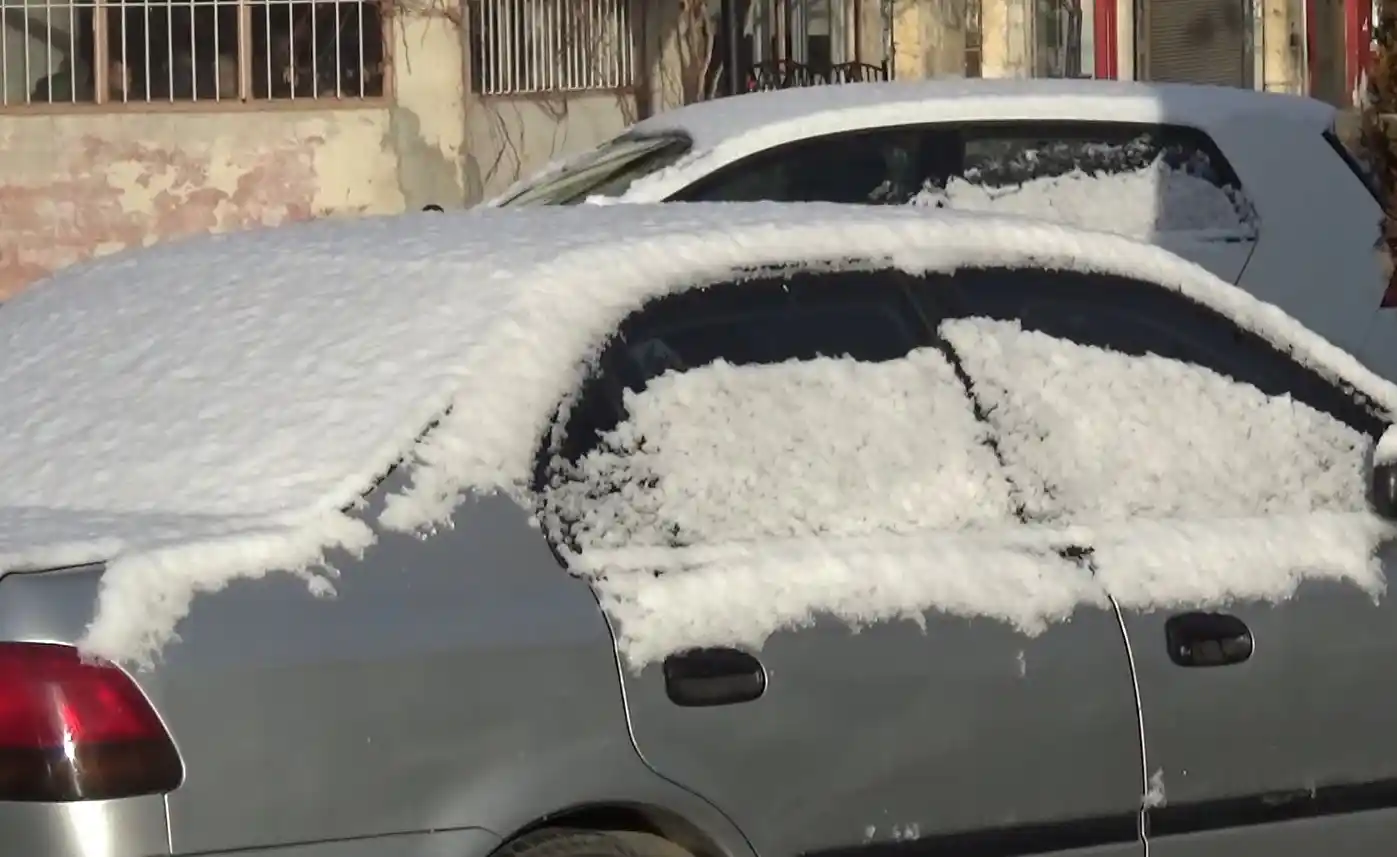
0 7 464 299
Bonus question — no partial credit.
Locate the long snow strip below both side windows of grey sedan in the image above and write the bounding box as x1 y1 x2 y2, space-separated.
574 513 1393 670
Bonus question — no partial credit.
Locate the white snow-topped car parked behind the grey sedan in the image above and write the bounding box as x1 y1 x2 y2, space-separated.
489 80 1397 380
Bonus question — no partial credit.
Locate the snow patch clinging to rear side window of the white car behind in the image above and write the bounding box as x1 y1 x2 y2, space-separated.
911 158 1255 238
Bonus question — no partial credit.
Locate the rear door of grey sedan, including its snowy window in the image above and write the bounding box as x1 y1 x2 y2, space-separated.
533 270 1144 857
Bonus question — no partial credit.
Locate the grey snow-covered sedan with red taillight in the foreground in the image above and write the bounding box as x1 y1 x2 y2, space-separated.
8 204 1397 857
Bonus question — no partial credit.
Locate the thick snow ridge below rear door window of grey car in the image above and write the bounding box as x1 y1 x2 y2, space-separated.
576 530 1108 668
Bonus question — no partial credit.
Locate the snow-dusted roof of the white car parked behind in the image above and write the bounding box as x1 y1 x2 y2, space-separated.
631 78 1336 150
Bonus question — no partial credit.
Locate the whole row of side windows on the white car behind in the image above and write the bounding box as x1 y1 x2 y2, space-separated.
673 122 1256 236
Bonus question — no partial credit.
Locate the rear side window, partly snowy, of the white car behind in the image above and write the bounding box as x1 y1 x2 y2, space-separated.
914 122 1256 238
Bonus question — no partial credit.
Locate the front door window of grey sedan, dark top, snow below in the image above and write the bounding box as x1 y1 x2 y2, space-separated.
929 270 1383 523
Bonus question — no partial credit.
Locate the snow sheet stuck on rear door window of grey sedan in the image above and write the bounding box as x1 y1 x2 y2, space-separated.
550 348 1013 547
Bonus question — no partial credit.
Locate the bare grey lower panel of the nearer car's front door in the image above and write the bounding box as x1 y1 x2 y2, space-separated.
1122 544 1397 857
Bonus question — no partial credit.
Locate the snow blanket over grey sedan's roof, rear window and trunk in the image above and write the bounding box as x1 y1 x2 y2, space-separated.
0 203 1397 663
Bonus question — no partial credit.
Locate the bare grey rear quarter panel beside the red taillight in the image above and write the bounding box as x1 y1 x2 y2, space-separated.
0 478 746 857
